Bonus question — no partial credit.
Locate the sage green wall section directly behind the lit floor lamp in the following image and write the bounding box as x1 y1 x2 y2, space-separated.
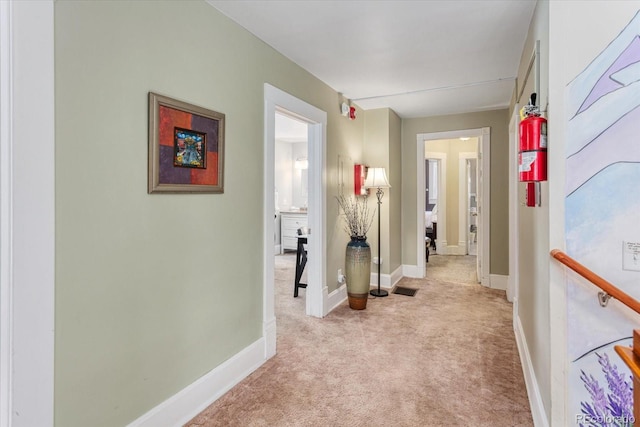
364 108 402 274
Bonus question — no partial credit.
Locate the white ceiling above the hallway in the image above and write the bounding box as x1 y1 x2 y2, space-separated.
207 0 536 118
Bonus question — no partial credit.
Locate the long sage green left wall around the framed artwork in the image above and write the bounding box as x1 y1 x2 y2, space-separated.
55 0 364 427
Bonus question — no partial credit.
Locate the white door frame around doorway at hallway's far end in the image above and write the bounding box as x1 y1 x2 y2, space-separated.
415 127 491 287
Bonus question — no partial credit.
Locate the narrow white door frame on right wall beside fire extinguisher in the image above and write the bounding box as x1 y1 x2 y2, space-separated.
507 104 520 306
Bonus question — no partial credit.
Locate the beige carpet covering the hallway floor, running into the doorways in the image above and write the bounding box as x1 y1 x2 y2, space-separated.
186 255 533 427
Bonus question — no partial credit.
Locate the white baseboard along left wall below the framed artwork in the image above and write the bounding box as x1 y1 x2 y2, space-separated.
127 338 266 427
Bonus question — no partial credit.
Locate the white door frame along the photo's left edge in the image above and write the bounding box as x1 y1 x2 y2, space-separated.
0 0 55 427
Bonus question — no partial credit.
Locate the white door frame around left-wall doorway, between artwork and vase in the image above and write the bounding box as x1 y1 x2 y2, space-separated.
263 83 327 357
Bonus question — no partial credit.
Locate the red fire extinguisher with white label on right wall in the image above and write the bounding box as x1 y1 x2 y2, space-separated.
518 93 547 182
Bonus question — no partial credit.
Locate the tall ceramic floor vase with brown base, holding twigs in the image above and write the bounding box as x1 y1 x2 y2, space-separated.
345 236 371 310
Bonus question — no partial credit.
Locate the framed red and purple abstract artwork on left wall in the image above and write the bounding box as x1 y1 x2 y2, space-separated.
147 92 225 194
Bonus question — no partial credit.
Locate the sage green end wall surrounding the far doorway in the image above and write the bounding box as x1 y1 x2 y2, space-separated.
402 109 509 275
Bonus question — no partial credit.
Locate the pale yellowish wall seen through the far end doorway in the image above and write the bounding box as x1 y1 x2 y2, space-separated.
425 138 478 246
